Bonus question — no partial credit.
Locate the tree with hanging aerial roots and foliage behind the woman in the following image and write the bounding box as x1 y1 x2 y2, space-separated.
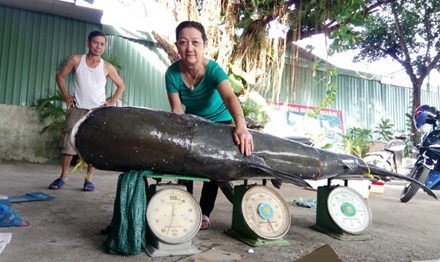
151 0 394 100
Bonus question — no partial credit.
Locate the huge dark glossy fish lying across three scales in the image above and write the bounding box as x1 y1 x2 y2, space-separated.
72 107 436 198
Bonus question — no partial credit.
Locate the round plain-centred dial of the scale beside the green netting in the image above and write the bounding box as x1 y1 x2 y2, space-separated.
147 188 202 244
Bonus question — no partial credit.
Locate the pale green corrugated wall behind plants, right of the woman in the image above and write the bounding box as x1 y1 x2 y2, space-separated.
256 61 440 130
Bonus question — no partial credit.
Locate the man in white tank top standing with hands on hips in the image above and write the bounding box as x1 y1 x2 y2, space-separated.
49 31 125 191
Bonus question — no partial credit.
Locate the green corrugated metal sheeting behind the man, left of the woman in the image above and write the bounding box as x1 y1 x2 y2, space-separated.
0 6 169 109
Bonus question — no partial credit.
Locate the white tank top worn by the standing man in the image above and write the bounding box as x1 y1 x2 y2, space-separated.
73 55 107 109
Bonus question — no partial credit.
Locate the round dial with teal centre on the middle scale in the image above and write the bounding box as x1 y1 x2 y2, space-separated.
241 185 291 240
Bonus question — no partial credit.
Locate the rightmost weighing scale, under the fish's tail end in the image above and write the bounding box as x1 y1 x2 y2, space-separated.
312 180 372 240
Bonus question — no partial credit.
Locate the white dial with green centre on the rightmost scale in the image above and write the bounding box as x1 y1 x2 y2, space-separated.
327 187 372 235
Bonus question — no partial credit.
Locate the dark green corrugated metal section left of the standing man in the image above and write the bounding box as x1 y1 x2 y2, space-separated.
0 6 100 106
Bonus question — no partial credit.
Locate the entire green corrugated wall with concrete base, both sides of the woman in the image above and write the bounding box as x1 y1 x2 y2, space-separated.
0 6 440 162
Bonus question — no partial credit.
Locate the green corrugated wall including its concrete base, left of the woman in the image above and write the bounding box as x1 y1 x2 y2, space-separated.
0 5 169 162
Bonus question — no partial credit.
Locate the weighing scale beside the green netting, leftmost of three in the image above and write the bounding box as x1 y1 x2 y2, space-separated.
146 176 204 257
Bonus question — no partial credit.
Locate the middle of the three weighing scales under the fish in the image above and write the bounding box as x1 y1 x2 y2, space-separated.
226 180 291 247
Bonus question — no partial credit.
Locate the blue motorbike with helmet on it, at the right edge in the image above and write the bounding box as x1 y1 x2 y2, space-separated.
400 105 440 203
